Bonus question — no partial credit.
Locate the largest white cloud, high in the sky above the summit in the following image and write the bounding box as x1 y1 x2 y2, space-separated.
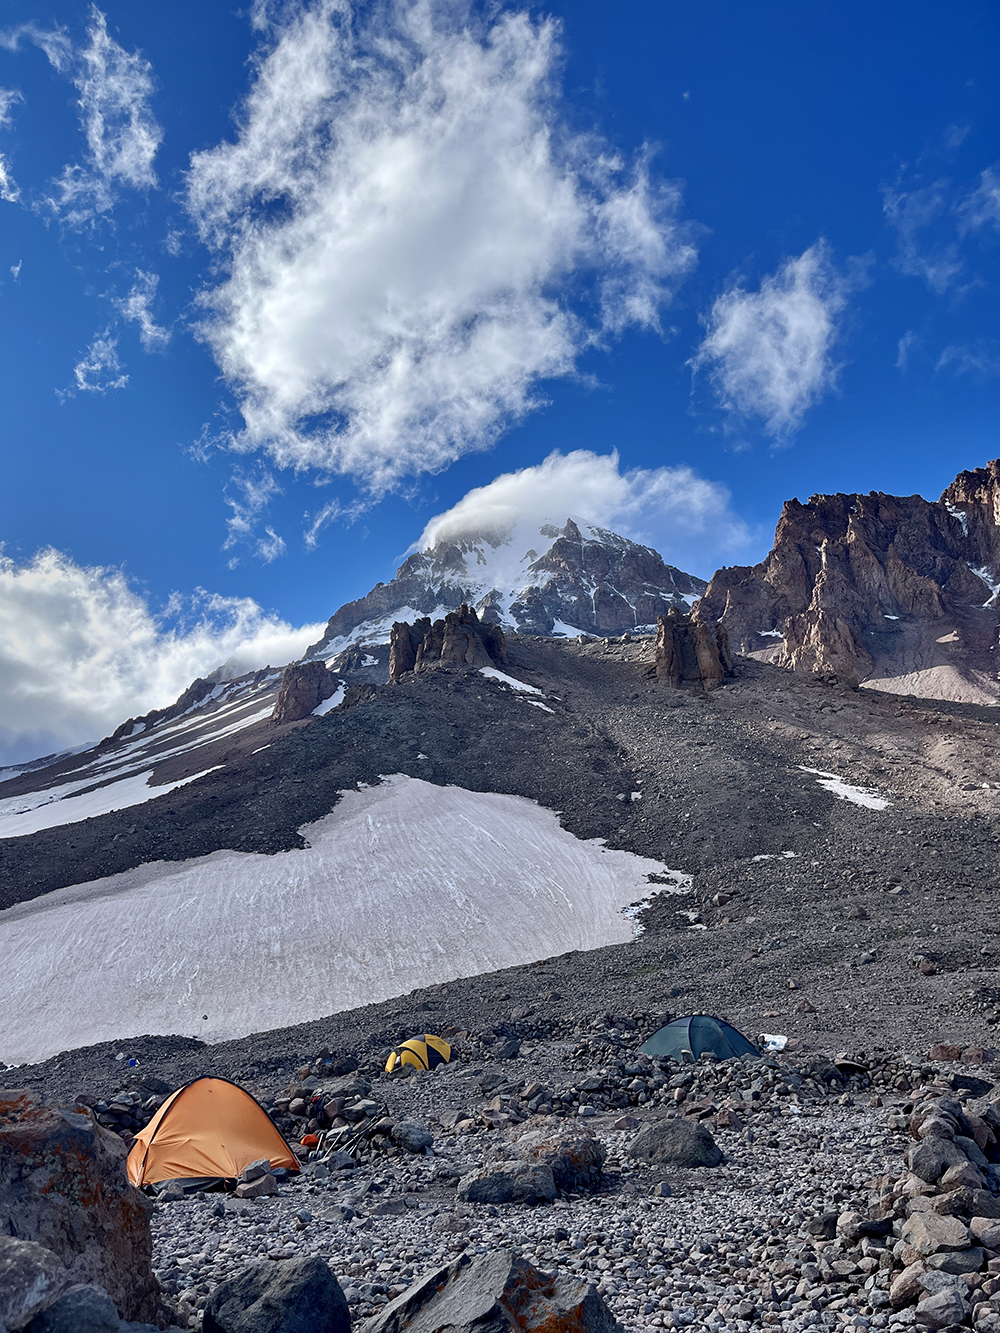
188 0 695 493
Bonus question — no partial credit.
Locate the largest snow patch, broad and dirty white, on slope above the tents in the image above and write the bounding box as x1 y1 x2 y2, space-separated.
0 776 691 1064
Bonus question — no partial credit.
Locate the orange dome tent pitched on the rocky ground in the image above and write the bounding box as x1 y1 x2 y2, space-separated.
128 1078 299 1185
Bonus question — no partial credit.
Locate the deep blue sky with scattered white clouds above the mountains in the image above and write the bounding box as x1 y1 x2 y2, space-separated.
0 0 1000 758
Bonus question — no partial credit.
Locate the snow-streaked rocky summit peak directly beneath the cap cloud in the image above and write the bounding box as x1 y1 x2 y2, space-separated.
307 519 707 657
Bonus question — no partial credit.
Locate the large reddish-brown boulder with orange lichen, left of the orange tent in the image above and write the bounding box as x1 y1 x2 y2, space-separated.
0 1089 160 1328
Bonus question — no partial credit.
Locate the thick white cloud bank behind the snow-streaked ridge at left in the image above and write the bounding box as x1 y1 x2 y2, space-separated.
0 551 323 764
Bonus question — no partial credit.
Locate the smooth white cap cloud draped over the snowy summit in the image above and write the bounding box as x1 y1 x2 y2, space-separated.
413 449 752 575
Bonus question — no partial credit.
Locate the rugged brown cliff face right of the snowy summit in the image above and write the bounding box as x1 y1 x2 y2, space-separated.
696 463 1000 702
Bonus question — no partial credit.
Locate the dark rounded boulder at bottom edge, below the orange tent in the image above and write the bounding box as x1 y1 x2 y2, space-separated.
201 1257 351 1333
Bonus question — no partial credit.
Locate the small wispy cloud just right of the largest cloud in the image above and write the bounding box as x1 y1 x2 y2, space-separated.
692 240 857 437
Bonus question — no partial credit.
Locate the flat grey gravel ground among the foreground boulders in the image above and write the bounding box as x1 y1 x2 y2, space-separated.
142 1042 954 1333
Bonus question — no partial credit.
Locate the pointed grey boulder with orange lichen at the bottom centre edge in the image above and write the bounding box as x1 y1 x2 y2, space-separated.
360 1250 623 1333
